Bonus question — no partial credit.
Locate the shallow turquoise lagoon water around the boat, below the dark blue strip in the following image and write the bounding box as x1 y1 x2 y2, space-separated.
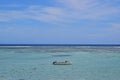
0 46 120 80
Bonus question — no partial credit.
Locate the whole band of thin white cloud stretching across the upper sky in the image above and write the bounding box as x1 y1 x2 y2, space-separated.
0 0 120 24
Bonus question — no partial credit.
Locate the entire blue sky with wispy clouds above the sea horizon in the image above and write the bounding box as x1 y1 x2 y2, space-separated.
0 0 120 44
